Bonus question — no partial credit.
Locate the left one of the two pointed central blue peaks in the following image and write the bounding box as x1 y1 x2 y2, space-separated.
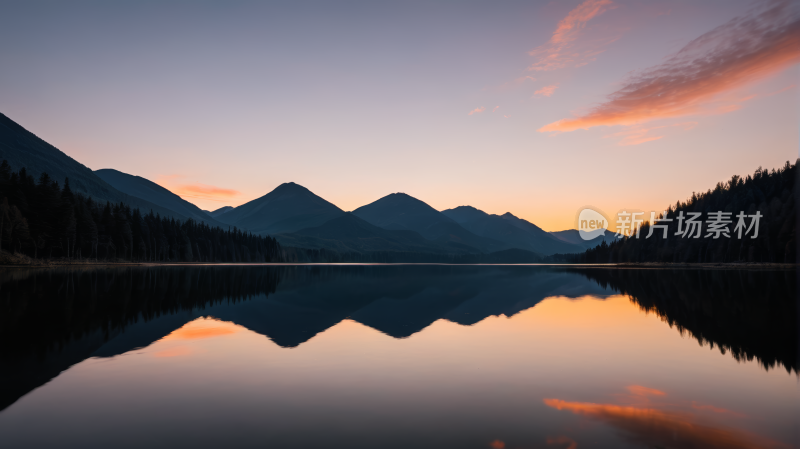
216 182 344 235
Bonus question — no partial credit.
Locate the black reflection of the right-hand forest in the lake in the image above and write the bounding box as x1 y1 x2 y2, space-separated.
582 269 798 372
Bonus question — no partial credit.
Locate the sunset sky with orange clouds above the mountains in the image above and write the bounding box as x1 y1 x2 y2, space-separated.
0 0 800 231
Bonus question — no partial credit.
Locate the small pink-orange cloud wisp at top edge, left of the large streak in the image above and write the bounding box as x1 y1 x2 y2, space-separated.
528 0 616 71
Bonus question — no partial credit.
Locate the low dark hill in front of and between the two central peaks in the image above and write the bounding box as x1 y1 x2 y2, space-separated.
275 212 472 254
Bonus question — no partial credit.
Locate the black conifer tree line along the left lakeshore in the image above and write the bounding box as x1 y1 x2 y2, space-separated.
0 160 282 262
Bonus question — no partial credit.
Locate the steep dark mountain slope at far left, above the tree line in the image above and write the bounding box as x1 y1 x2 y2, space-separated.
0 113 187 220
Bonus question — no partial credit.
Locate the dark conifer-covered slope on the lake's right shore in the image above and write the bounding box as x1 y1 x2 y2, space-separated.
545 161 798 263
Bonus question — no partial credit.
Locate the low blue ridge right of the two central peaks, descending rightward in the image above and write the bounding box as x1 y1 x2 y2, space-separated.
442 206 586 255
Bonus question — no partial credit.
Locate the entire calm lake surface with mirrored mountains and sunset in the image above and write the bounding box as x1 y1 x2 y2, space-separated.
0 266 800 449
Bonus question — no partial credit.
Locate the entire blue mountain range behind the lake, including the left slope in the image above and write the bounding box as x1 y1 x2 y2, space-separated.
0 114 601 260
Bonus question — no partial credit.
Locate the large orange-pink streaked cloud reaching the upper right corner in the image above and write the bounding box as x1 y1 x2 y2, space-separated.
539 0 800 132
